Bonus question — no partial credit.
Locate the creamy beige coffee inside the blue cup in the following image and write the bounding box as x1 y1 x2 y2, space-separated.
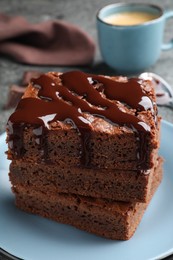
104 12 158 26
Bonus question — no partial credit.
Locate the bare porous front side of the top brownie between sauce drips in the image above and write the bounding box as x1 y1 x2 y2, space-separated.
8 125 158 170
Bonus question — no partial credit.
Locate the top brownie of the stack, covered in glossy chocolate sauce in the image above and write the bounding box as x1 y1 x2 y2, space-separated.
7 71 159 170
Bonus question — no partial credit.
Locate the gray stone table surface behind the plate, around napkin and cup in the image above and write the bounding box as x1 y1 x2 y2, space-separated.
0 0 173 260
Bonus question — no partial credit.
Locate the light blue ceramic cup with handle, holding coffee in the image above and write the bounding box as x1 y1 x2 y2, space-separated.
97 3 173 74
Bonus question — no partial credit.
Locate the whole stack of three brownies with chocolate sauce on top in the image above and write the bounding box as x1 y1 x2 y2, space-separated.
7 71 162 240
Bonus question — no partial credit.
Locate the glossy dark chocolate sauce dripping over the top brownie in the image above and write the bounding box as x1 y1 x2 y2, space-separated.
8 71 153 168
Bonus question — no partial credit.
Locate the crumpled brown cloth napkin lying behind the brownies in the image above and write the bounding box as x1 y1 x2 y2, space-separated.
0 14 95 65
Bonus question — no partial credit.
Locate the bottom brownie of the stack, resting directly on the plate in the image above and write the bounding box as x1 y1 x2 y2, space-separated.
13 159 162 240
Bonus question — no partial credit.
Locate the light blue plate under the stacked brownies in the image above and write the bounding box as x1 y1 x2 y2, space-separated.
0 121 173 260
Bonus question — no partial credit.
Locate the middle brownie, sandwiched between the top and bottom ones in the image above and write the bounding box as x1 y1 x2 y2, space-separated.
9 157 158 202
